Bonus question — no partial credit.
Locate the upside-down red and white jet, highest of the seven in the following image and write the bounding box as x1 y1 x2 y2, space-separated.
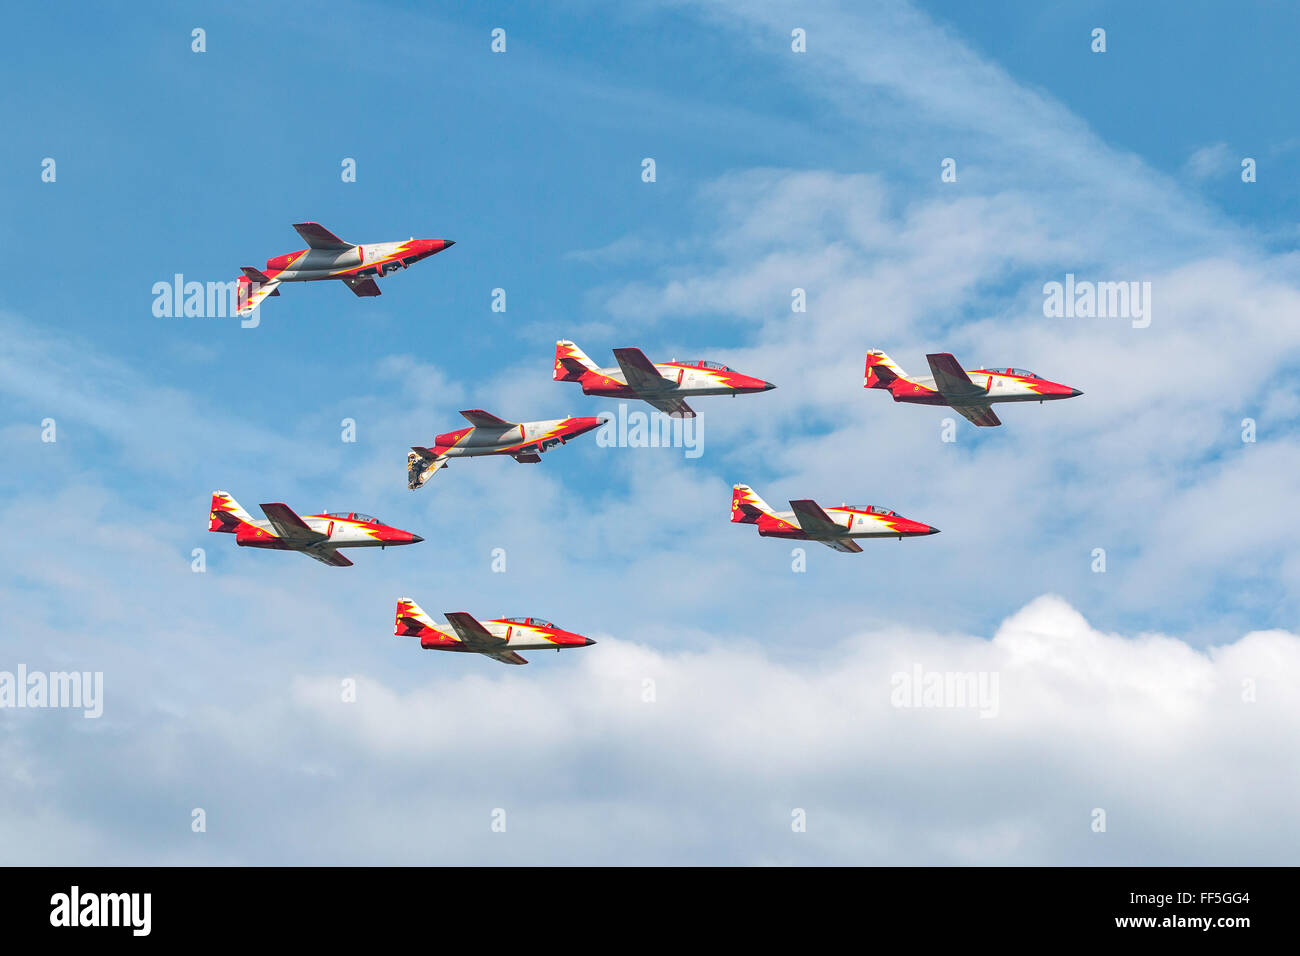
238 222 456 315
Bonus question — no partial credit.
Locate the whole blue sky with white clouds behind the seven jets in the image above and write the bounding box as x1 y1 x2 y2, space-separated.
0 3 1300 862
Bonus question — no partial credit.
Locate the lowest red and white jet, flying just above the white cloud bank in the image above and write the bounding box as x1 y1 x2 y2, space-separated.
393 597 595 663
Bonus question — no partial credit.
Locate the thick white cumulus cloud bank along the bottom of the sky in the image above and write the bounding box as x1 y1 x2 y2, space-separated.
5 596 1300 865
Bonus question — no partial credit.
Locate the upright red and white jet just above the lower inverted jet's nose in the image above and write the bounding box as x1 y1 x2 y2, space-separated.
554 339 776 419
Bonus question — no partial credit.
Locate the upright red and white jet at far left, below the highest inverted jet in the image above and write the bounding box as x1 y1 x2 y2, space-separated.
208 492 424 567
